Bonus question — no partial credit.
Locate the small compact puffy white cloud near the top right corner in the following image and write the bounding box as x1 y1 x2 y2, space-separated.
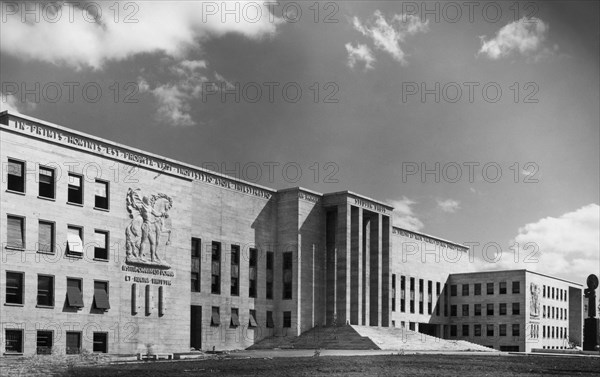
477 17 558 61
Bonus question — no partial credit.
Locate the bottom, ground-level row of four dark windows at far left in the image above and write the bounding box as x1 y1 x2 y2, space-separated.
5 329 108 355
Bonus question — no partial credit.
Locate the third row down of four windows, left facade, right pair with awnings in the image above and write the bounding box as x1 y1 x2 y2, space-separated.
6 271 110 311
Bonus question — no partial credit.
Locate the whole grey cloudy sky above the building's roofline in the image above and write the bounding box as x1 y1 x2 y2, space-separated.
0 1 600 284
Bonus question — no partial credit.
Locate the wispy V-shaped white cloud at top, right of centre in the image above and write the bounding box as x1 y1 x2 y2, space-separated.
346 10 429 65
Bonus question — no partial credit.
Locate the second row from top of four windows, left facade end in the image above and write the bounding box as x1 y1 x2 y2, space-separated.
6 214 109 260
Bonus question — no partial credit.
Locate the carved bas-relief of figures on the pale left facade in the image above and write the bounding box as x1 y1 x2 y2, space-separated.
125 188 173 269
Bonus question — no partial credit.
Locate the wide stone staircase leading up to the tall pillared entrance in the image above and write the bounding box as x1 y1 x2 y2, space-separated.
248 325 494 352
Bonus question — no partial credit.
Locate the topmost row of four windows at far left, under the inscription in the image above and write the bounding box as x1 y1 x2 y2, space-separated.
6 158 109 210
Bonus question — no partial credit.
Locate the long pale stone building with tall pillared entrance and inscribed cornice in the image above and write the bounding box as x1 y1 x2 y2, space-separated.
0 112 582 355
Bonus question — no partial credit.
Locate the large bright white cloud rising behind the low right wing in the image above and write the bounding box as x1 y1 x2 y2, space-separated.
490 204 600 280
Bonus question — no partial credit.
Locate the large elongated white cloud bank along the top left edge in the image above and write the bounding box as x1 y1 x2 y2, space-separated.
0 1 282 69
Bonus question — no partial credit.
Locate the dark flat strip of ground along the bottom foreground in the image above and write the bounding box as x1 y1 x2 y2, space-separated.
5 355 600 377
